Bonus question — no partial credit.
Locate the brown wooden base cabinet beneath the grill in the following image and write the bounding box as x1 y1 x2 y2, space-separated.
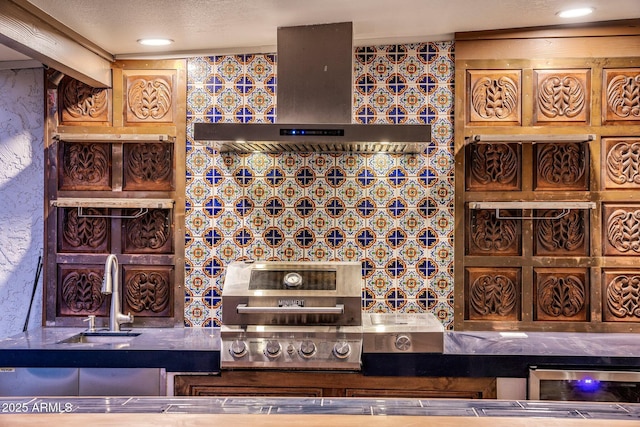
174 371 496 399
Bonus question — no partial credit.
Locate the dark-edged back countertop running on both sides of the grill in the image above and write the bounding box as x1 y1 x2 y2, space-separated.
0 328 640 378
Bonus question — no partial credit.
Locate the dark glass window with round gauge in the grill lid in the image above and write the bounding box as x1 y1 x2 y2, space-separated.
249 270 336 291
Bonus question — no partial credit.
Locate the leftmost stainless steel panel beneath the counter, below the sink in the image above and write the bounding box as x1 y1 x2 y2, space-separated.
0 368 78 396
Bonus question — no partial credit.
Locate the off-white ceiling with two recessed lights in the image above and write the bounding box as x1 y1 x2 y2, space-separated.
0 0 640 61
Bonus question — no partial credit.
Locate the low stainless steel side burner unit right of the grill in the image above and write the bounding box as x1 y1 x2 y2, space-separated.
362 313 444 354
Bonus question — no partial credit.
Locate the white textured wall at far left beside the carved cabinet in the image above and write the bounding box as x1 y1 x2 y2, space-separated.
0 69 44 338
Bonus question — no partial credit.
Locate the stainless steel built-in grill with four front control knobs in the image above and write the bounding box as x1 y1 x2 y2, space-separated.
220 261 363 370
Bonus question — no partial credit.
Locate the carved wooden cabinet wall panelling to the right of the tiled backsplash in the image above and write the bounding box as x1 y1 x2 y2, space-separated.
454 34 640 332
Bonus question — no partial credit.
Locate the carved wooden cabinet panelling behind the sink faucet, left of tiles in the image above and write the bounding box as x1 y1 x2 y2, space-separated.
44 61 186 327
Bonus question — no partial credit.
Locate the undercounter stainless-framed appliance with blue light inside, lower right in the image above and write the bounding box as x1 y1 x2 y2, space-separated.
529 369 640 403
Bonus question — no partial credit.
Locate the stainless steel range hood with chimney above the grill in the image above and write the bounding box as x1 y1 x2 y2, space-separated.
193 22 431 153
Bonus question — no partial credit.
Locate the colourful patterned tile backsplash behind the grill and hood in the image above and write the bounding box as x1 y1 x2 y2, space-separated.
184 42 454 328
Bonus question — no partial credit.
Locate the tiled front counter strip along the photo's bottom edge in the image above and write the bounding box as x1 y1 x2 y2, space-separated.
0 397 640 426
